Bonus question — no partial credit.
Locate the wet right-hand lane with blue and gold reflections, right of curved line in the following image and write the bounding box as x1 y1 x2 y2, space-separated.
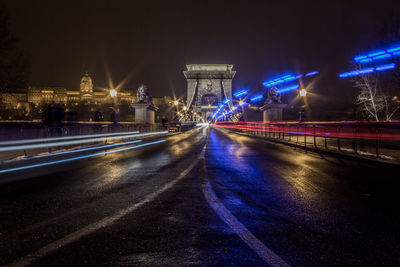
206 131 400 266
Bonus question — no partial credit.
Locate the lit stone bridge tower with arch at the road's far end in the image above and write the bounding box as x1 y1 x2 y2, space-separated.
183 64 236 121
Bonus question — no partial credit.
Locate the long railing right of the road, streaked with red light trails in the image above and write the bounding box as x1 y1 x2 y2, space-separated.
212 121 400 162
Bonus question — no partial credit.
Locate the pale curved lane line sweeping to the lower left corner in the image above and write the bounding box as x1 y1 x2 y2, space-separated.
4 153 200 267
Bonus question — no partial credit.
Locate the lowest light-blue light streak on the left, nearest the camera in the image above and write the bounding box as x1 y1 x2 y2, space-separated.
0 140 166 173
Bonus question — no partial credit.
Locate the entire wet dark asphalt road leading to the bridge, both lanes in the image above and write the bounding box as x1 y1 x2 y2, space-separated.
0 127 400 266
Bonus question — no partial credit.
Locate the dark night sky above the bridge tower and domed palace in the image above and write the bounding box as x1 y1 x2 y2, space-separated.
3 0 400 115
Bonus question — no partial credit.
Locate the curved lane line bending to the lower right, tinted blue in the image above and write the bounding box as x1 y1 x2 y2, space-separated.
202 156 290 266
